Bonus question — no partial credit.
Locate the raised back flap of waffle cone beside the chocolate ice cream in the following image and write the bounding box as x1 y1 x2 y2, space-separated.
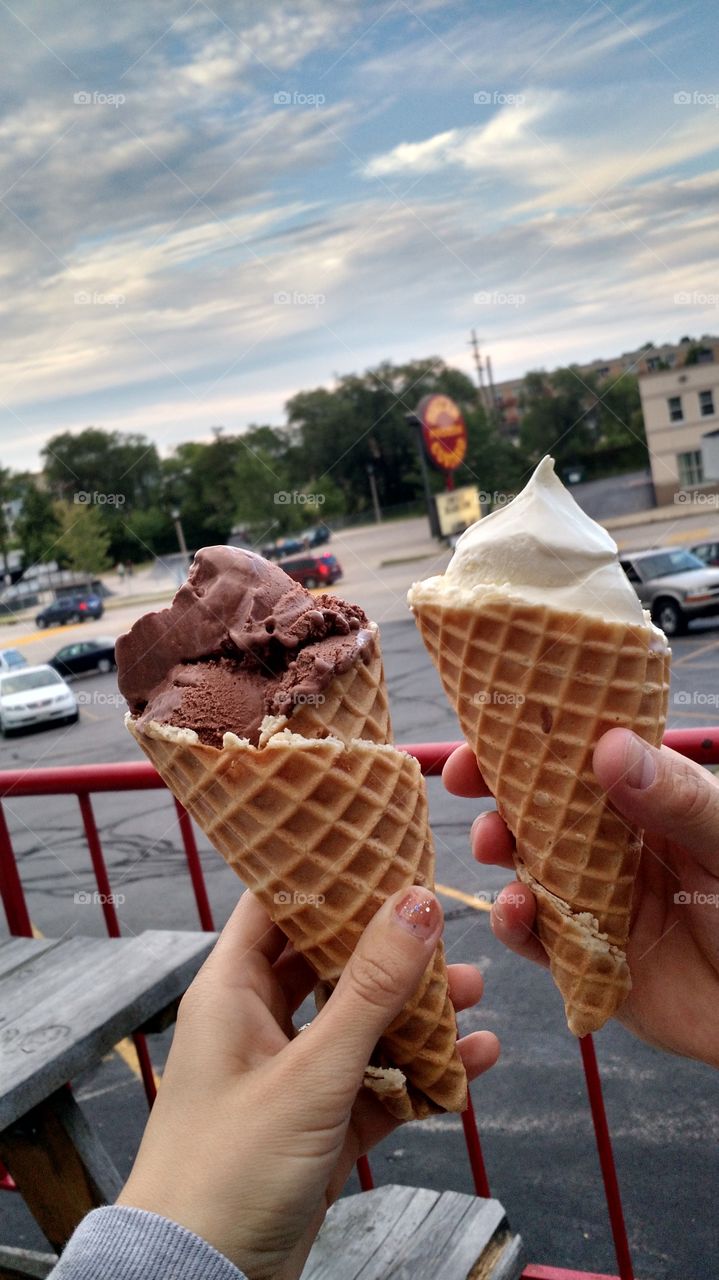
260 623 391 746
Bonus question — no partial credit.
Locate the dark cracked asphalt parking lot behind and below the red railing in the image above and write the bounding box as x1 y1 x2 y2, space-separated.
0 564 719 1280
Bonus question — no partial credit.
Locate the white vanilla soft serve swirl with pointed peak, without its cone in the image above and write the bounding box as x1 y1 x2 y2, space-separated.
409 457 651 626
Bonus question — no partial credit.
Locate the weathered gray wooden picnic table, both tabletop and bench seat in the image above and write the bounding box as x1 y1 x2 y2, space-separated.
0 931 522 1280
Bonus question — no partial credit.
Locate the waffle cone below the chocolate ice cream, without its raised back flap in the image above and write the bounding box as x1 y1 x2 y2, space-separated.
127 717 467 1119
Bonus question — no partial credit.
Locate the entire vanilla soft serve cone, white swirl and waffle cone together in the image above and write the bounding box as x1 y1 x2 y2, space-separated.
409 458 670 1036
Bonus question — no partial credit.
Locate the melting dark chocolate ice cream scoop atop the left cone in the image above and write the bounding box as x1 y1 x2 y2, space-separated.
115 547 375 746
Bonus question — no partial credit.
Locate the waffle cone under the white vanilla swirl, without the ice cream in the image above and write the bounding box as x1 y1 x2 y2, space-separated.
413 596 670 1036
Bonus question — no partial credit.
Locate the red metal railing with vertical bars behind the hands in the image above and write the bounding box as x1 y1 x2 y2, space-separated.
0 728 719 1280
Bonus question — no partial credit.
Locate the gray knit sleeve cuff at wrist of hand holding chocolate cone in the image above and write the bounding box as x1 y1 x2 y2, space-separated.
47 1204 247 1280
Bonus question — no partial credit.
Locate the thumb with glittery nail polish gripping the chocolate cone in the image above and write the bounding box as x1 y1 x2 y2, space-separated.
294 886 444 1097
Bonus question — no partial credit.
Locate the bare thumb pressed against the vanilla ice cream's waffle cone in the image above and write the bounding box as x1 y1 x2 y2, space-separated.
594 728 719 874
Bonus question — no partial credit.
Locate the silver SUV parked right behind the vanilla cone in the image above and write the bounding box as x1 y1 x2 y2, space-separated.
619 547 719 636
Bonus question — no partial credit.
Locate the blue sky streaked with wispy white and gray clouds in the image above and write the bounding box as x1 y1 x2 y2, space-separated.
0 0 719 468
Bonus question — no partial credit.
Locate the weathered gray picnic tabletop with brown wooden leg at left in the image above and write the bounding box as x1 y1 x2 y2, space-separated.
0 931 215 1280
